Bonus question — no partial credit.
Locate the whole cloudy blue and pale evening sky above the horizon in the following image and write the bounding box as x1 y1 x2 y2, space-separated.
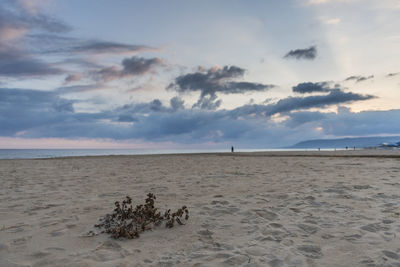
0 0 400 149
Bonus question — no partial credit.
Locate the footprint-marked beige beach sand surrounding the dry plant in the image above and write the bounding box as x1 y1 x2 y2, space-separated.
0 150 400 266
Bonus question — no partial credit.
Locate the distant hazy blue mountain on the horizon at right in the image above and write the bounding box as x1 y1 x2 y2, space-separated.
290 136 400 148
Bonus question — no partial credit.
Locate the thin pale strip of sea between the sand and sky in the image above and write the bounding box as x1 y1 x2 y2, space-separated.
0 148 318 159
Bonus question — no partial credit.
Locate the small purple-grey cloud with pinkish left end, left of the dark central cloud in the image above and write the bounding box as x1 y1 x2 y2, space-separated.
91 56 163 81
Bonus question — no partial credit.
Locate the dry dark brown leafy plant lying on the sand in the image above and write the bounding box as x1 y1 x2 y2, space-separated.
95 193 189 239
